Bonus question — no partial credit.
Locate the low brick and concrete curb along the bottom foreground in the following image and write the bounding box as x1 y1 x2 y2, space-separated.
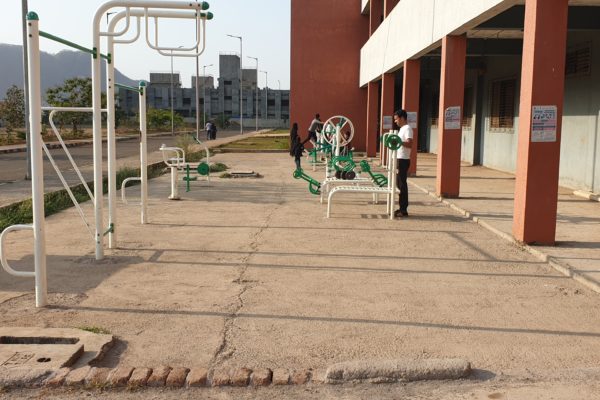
1 359 471 390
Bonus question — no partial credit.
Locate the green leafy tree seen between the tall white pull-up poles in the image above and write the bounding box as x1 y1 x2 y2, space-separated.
46 78 106 133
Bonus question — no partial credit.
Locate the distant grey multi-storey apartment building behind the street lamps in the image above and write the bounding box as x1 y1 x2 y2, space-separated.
118 54 290 128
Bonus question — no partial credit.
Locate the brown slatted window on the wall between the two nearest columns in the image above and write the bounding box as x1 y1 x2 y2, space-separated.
490 79 517 129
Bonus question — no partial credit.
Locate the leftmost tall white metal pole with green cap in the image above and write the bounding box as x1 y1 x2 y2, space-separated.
27 13 48 307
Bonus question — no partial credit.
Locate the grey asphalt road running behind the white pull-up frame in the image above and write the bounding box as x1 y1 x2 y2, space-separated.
0 131 239 183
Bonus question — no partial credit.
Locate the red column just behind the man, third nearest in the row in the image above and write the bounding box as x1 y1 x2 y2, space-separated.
402 60 421 176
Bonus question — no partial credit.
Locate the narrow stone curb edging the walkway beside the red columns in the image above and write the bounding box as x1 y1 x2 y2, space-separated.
408 179 600 293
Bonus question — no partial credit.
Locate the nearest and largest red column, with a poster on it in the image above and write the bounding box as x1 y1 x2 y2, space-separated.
513 0 569 244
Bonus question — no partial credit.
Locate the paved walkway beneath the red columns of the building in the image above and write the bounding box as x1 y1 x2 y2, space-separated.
410 154 600 292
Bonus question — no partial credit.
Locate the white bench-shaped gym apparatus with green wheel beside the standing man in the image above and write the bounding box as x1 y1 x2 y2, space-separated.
327 135 402 219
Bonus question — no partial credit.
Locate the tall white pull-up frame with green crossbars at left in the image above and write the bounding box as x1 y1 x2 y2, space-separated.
0 0 212 307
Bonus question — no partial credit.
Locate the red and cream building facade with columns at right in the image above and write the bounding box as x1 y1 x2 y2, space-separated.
291 0 600 243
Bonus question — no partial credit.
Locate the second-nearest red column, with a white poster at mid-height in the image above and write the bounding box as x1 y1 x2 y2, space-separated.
436 35 467 197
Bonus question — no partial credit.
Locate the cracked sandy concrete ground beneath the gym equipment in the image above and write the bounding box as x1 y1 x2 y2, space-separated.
0 154 600 399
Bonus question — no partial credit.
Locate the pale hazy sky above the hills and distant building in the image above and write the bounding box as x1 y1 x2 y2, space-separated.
0 0 290 89
